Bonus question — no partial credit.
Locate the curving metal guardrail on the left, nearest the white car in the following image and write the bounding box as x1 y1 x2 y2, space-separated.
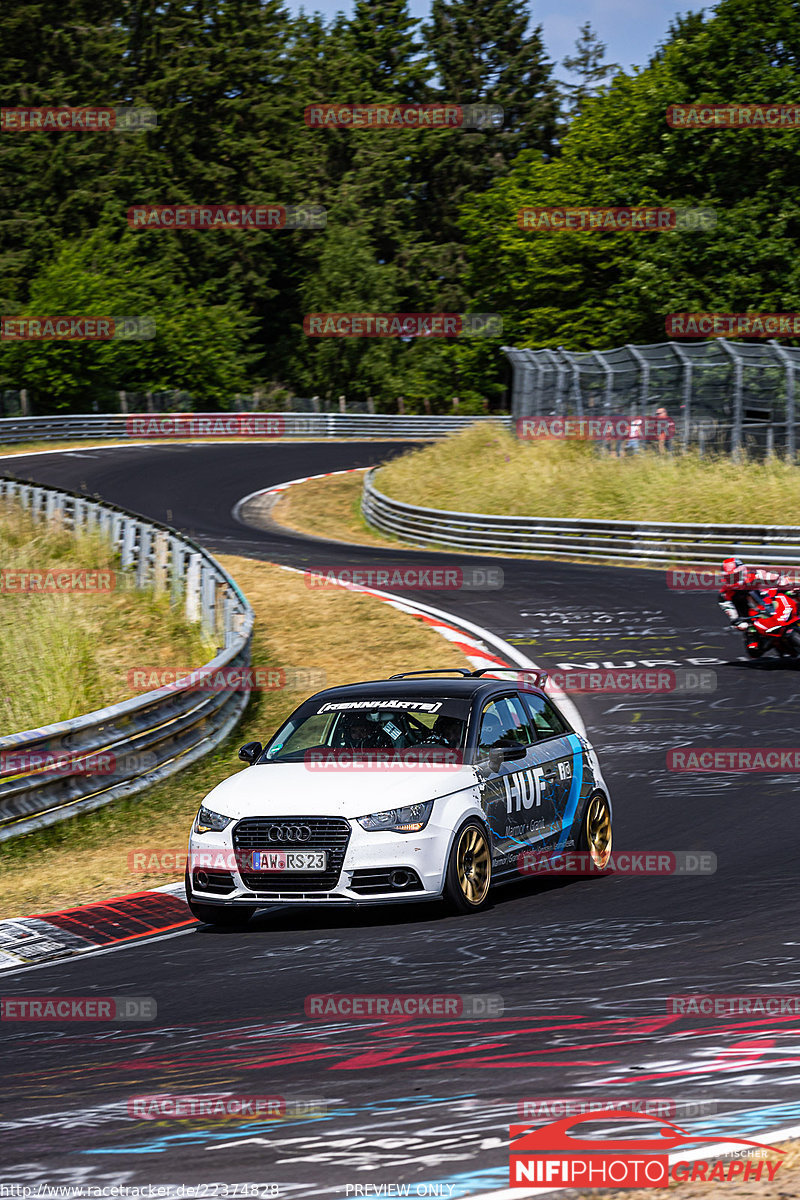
0 476 253 841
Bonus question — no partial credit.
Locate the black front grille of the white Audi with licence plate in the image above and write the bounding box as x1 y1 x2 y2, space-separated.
233 817 351 893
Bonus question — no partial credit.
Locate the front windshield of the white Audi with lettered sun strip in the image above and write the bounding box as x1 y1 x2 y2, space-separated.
260 696 469 762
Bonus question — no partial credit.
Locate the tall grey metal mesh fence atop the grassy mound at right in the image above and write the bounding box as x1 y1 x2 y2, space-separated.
503 337 800 457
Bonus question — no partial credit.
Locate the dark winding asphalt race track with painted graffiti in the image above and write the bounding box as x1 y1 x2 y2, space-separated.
0 443 800 1200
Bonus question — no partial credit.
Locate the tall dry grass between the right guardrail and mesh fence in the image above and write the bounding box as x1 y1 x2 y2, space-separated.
377 425 800 523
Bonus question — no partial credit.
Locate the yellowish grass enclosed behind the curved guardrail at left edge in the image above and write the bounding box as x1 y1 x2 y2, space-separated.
0 505 215 732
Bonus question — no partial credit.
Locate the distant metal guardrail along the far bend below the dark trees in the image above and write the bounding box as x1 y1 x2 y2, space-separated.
0 413 511 446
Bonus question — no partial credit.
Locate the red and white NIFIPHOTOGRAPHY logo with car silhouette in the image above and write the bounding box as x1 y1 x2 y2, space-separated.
509 1108 784 1188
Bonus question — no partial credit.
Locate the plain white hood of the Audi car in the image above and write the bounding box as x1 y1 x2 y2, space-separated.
203 762 477 820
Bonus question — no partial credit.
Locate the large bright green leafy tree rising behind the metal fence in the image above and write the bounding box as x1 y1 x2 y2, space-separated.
463 0 800 349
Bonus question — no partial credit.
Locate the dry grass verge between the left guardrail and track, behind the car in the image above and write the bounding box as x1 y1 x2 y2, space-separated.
0 556 469 917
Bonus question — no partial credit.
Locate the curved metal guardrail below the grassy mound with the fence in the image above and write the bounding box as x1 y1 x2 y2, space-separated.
361 468 800 566
